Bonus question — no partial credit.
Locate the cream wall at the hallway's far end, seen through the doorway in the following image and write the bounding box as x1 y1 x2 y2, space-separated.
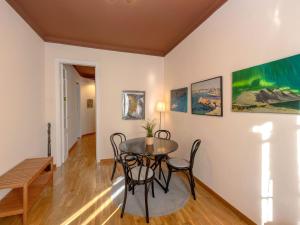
80 78 96 135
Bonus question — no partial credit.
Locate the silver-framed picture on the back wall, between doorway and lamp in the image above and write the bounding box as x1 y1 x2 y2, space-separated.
122 91 145 120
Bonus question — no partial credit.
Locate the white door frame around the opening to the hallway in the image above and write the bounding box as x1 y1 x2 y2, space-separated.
53 59 101 166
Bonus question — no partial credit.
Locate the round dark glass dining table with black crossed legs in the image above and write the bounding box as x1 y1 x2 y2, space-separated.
119 137 178 191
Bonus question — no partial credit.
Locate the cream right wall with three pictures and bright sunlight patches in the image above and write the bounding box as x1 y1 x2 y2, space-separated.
165 0 300 224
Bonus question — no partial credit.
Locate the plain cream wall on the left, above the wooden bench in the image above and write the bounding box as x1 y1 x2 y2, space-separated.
0 1 47 197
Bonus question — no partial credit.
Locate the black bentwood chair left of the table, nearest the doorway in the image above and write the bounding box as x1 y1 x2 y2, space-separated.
110 133 136 180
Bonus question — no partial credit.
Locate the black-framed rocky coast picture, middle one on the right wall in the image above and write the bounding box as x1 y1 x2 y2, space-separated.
191 76 223 116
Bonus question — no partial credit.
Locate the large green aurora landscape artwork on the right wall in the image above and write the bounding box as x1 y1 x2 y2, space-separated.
232 54 300 114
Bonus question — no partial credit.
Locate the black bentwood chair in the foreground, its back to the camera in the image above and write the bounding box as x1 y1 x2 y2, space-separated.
121 153 155 223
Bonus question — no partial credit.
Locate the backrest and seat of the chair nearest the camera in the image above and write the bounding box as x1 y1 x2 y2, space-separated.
121 153 151 184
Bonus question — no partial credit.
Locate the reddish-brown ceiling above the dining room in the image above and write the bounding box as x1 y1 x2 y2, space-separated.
7 0 227 56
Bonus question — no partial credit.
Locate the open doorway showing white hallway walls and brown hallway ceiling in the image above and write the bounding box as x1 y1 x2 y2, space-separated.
61 63 96 163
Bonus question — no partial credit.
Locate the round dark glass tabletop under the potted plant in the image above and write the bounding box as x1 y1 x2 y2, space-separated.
119 137 178 156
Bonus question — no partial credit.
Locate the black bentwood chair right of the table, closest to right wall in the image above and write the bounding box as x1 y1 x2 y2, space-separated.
166 139 201 200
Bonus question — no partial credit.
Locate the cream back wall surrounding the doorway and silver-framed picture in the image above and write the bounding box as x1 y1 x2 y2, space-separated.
45 43 164 164
